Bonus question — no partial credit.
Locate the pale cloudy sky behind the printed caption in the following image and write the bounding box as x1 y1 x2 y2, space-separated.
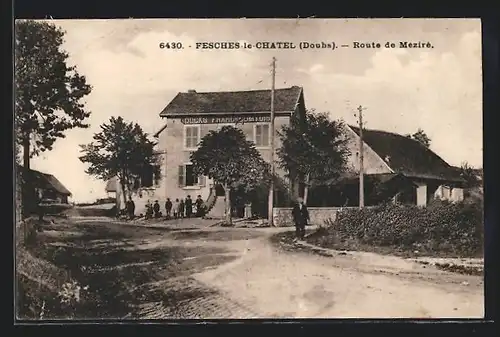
25 19 482 202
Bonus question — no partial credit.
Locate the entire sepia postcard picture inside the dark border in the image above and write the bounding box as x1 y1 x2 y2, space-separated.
12 18 484 323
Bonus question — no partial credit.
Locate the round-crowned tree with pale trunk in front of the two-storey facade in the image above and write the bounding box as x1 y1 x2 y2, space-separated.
191 126 270 225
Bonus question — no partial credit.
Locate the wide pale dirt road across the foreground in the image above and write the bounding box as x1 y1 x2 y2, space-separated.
34 220 484 319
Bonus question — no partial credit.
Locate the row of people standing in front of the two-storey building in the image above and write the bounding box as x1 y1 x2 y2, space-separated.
126 195 205 219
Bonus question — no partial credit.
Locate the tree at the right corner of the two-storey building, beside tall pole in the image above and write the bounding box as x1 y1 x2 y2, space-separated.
277 110 349 202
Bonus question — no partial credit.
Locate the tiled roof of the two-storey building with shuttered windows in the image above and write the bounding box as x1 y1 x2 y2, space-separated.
160 86 302 117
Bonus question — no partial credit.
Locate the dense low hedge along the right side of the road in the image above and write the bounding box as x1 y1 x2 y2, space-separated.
318 201 484 257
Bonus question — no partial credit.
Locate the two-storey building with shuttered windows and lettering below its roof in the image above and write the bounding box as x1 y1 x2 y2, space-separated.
107 86 305 213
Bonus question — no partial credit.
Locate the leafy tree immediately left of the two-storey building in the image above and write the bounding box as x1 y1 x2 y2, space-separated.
80 117 160 207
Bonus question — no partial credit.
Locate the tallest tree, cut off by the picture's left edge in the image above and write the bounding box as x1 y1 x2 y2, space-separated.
14 20 91 215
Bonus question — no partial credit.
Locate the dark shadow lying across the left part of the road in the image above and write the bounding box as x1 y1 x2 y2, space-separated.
29 223 238 318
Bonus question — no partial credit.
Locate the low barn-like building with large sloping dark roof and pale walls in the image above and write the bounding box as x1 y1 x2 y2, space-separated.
322 126 464 206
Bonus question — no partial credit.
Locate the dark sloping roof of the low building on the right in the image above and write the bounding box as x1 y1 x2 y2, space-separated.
349 126 463 182
